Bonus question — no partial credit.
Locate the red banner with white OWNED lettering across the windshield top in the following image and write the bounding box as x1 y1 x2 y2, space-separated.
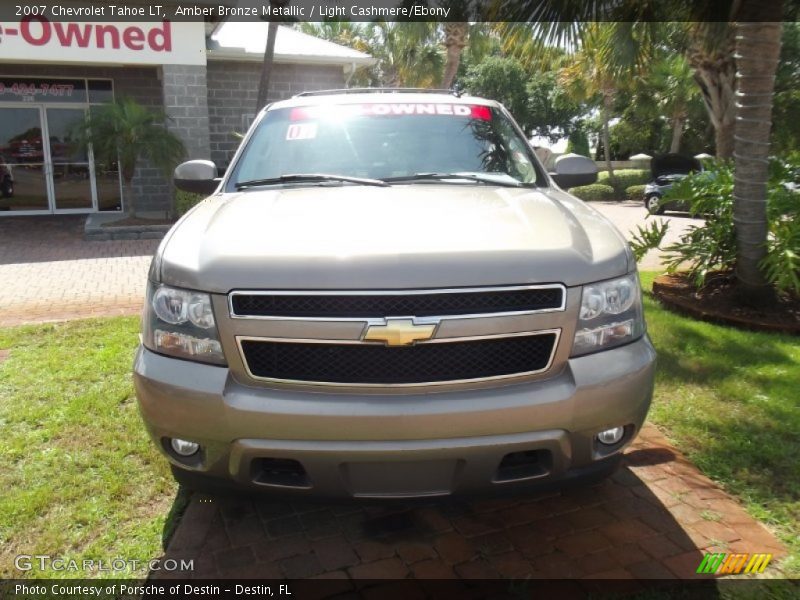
287 102 492 121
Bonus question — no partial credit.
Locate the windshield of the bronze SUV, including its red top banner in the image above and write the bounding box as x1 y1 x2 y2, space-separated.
228 102 546 190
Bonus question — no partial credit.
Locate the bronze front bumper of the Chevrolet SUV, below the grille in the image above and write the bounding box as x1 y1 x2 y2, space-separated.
134 336 655 497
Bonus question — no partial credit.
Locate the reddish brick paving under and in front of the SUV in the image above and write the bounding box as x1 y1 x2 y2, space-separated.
165 426 784 589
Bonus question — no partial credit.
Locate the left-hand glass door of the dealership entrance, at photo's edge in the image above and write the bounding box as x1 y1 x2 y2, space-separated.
0 106 48 212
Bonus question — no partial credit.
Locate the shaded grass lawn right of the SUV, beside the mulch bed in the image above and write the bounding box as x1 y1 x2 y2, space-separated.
642 273 800 577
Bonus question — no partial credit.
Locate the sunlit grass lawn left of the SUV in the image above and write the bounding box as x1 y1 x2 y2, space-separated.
0 318 183 578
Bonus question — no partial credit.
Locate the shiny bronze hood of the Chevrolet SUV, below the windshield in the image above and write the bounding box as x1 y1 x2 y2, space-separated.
156 184 632 293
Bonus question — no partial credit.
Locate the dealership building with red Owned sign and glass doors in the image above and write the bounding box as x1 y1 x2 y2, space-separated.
0 16 374 217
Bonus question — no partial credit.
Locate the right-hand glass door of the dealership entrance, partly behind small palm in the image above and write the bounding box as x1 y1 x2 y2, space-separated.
45 107 93 212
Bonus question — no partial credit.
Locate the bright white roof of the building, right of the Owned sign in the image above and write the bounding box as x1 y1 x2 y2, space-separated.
207 21 376 67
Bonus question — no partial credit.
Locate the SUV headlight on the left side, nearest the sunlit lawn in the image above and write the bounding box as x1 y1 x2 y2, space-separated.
142 283 226 365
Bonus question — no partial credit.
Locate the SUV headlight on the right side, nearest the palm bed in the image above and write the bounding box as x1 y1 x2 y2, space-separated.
572 272 645 356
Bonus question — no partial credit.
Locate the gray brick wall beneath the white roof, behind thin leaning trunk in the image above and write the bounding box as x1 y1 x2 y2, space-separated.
207 60 345 167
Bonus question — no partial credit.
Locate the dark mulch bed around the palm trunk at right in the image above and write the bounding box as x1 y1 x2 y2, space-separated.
653 273 800 335
